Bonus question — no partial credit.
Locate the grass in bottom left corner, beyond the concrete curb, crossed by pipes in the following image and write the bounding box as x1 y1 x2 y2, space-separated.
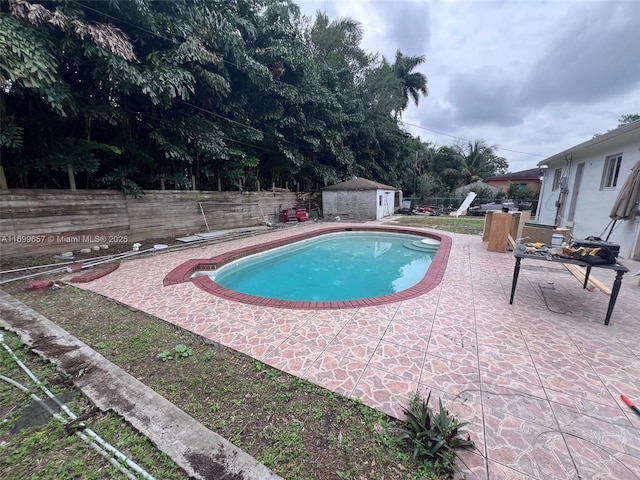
0 330 187 480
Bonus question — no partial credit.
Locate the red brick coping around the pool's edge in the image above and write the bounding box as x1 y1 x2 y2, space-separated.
162 225 451 310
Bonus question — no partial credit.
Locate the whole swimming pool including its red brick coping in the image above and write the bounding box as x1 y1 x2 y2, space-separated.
163 225 451 309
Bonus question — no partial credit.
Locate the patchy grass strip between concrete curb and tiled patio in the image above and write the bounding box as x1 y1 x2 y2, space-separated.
0 281 470 480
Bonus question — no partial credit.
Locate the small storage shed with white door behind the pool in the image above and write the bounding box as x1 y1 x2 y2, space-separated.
322 177 402 221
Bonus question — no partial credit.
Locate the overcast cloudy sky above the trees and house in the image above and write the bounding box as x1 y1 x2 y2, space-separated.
294 0 640 172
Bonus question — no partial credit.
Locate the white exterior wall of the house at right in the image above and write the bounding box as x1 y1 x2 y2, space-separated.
538 136 640 258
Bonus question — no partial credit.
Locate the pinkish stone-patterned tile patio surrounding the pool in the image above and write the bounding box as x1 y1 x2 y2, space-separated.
72 224 640 480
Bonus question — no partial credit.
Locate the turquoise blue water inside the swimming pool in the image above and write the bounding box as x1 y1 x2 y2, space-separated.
198 232 439 302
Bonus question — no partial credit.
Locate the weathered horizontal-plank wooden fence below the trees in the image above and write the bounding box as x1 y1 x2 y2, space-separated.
0 189 298 255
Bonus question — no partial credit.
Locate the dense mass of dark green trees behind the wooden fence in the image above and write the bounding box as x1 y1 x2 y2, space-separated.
0 0 506 195
